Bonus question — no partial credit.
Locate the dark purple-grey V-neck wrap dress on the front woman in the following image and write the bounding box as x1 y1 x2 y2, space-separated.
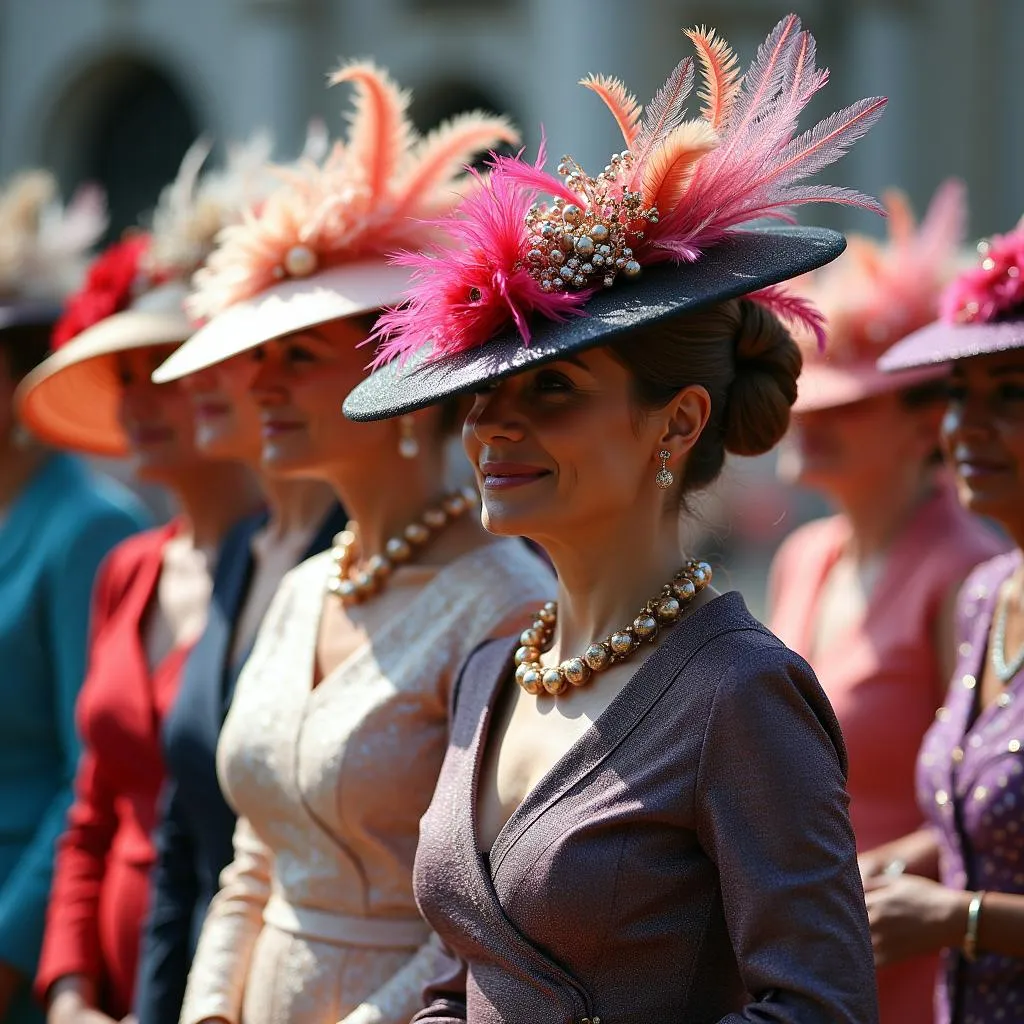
414 593 878 1024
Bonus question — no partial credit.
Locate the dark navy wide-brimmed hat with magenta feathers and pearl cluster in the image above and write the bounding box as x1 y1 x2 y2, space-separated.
344 14 886 420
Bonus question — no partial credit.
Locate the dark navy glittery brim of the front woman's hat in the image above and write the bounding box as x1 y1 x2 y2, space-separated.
343 227 846 422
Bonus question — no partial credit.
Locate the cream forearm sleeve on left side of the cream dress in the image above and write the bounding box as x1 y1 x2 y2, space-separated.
180 818 273 1024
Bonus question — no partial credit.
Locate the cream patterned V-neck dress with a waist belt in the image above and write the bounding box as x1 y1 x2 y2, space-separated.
181 541 555 1024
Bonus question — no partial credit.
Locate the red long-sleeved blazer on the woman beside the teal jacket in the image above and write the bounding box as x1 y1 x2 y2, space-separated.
36 523 187 1020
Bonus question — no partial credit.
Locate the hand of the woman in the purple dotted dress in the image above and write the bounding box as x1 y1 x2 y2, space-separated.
864 874 971 967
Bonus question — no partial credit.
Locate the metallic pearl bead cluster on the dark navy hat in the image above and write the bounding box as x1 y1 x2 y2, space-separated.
526 150 658 292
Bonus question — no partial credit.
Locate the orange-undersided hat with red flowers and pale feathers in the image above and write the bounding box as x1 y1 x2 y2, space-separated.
15 135 280 457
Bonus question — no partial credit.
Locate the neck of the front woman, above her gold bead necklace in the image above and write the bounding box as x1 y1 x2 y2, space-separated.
539 503 685 658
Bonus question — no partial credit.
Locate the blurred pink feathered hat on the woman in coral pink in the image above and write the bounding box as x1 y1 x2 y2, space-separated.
794 180 966 414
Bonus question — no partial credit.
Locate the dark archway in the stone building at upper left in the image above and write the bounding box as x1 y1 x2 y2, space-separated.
44 54 200 240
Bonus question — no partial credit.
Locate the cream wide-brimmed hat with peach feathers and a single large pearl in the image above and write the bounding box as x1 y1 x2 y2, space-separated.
154 61 518 381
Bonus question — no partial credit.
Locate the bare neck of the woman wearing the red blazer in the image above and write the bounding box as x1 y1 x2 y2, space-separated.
168 461 262 551
